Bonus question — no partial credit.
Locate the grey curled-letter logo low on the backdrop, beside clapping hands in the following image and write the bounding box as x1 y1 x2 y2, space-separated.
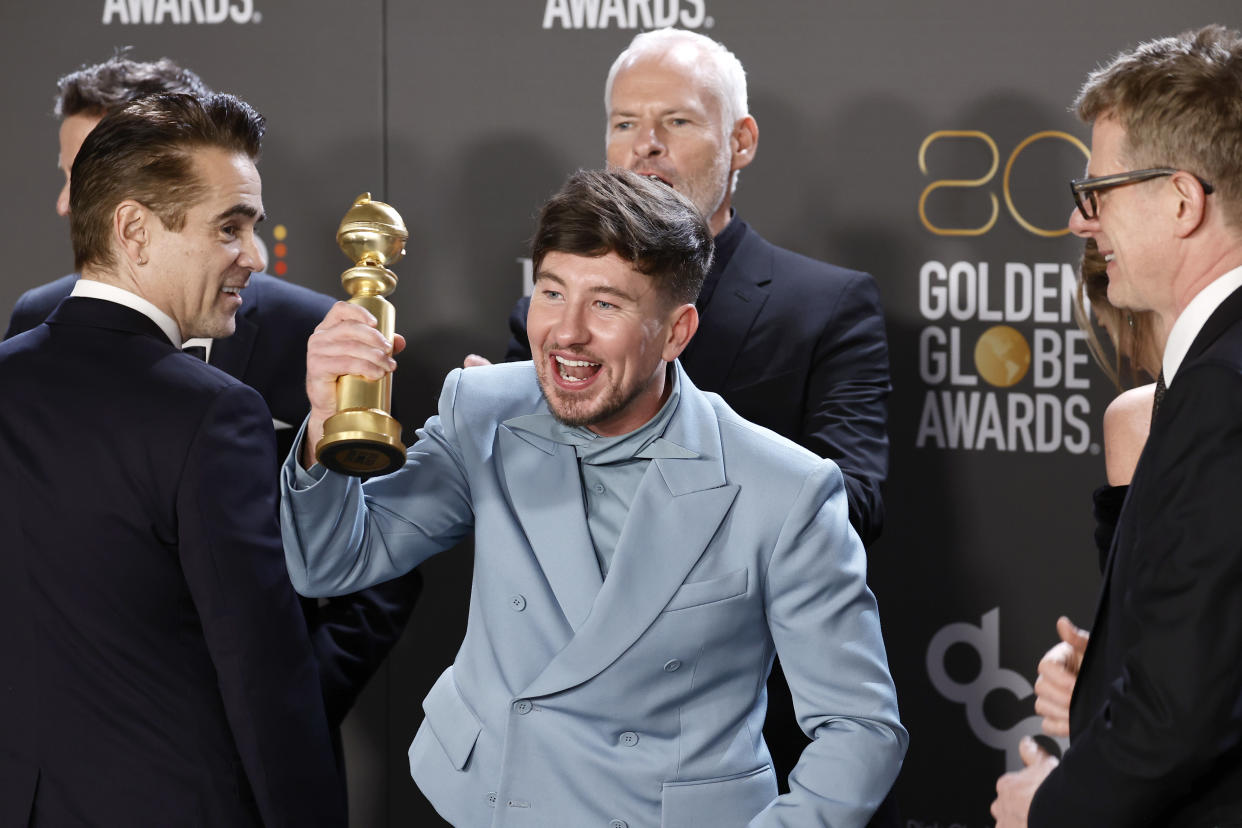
927 607 1069 771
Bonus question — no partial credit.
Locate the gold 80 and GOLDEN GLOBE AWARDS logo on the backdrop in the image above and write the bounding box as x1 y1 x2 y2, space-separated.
915 130 1099 454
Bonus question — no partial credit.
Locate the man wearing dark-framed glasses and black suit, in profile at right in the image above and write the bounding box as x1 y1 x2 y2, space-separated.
992 26 1242 828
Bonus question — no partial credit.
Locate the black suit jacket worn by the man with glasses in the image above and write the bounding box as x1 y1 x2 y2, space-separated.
1030 290 1242 828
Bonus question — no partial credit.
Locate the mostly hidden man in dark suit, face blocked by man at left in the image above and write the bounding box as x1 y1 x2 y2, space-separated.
5 57 422 750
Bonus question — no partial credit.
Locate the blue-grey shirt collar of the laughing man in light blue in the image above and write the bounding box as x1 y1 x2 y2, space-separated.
503 364 698 466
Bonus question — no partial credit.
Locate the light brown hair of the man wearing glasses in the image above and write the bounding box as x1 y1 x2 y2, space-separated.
1074 25 1242 228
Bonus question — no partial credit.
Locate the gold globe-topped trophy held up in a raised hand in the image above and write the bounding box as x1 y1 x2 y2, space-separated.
314 192 410 477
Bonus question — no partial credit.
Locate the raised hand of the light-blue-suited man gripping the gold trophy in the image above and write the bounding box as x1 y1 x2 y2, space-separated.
302 302 405 468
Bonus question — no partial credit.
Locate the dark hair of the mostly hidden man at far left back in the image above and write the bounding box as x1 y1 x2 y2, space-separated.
53 55 211 118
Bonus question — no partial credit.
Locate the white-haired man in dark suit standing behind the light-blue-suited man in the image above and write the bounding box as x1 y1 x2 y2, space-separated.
467 29 897 824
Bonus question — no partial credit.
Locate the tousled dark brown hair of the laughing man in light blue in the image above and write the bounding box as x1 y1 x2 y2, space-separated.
530 169 714 304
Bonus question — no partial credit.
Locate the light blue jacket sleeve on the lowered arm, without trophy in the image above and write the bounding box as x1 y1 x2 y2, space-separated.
750 463 908 828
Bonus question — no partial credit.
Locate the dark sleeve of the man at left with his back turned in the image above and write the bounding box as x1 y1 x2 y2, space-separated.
176 385 345 827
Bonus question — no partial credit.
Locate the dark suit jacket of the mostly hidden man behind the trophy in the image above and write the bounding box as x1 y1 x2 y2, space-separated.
5 273 422 726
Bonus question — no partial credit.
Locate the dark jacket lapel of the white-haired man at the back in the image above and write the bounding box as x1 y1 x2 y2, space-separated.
682 227 773 391
